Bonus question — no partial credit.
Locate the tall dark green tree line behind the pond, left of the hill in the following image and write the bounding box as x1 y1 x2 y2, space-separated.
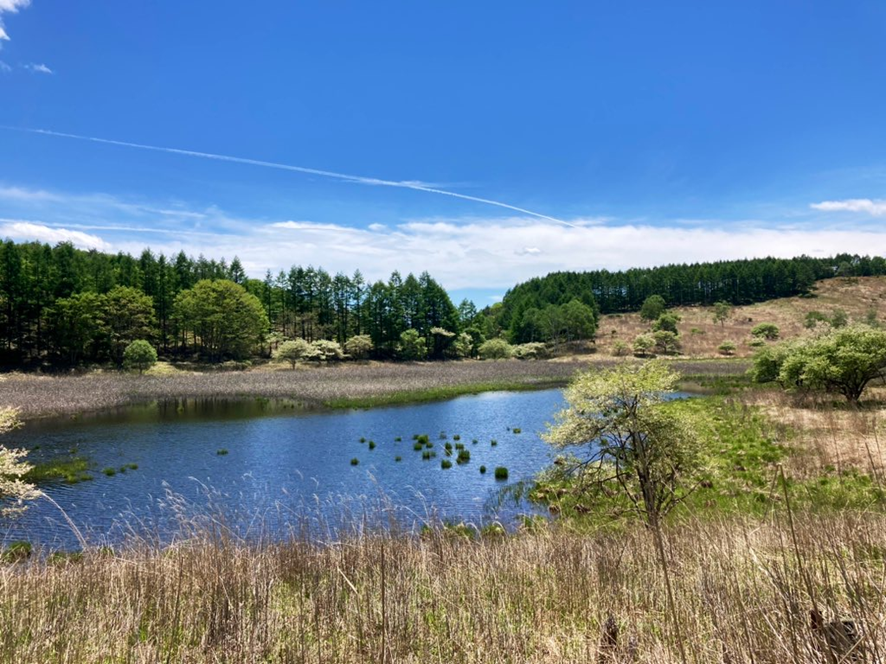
0 241 496 367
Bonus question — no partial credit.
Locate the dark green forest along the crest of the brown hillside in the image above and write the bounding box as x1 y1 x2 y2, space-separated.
496 254 886 343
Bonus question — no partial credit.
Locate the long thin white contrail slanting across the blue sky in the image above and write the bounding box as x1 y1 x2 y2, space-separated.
0 126 580 228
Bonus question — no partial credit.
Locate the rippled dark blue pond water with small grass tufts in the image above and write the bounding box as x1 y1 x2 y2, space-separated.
0 389 563 548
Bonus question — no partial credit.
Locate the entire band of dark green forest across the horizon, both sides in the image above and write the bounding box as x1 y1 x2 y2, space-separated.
0 241 886 368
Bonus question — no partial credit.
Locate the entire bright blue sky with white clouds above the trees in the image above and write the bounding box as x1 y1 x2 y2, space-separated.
0 0 886 305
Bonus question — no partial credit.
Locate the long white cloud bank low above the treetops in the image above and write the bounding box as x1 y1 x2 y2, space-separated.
100 219 886 289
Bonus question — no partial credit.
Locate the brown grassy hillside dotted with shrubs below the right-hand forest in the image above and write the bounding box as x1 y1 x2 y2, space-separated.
597 277 886 357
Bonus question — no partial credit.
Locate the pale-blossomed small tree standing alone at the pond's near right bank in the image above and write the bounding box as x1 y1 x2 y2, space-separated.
544 361 701 527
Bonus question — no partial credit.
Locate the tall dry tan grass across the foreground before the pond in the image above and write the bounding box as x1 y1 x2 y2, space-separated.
0 510 886 664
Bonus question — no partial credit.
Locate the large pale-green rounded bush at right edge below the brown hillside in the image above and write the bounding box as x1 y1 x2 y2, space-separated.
778 325 886 403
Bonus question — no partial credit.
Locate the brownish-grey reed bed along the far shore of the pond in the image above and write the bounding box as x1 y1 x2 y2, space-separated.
0 356 745 422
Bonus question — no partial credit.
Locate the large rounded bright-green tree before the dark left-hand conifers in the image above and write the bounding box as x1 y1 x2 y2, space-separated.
175 279 268 361
